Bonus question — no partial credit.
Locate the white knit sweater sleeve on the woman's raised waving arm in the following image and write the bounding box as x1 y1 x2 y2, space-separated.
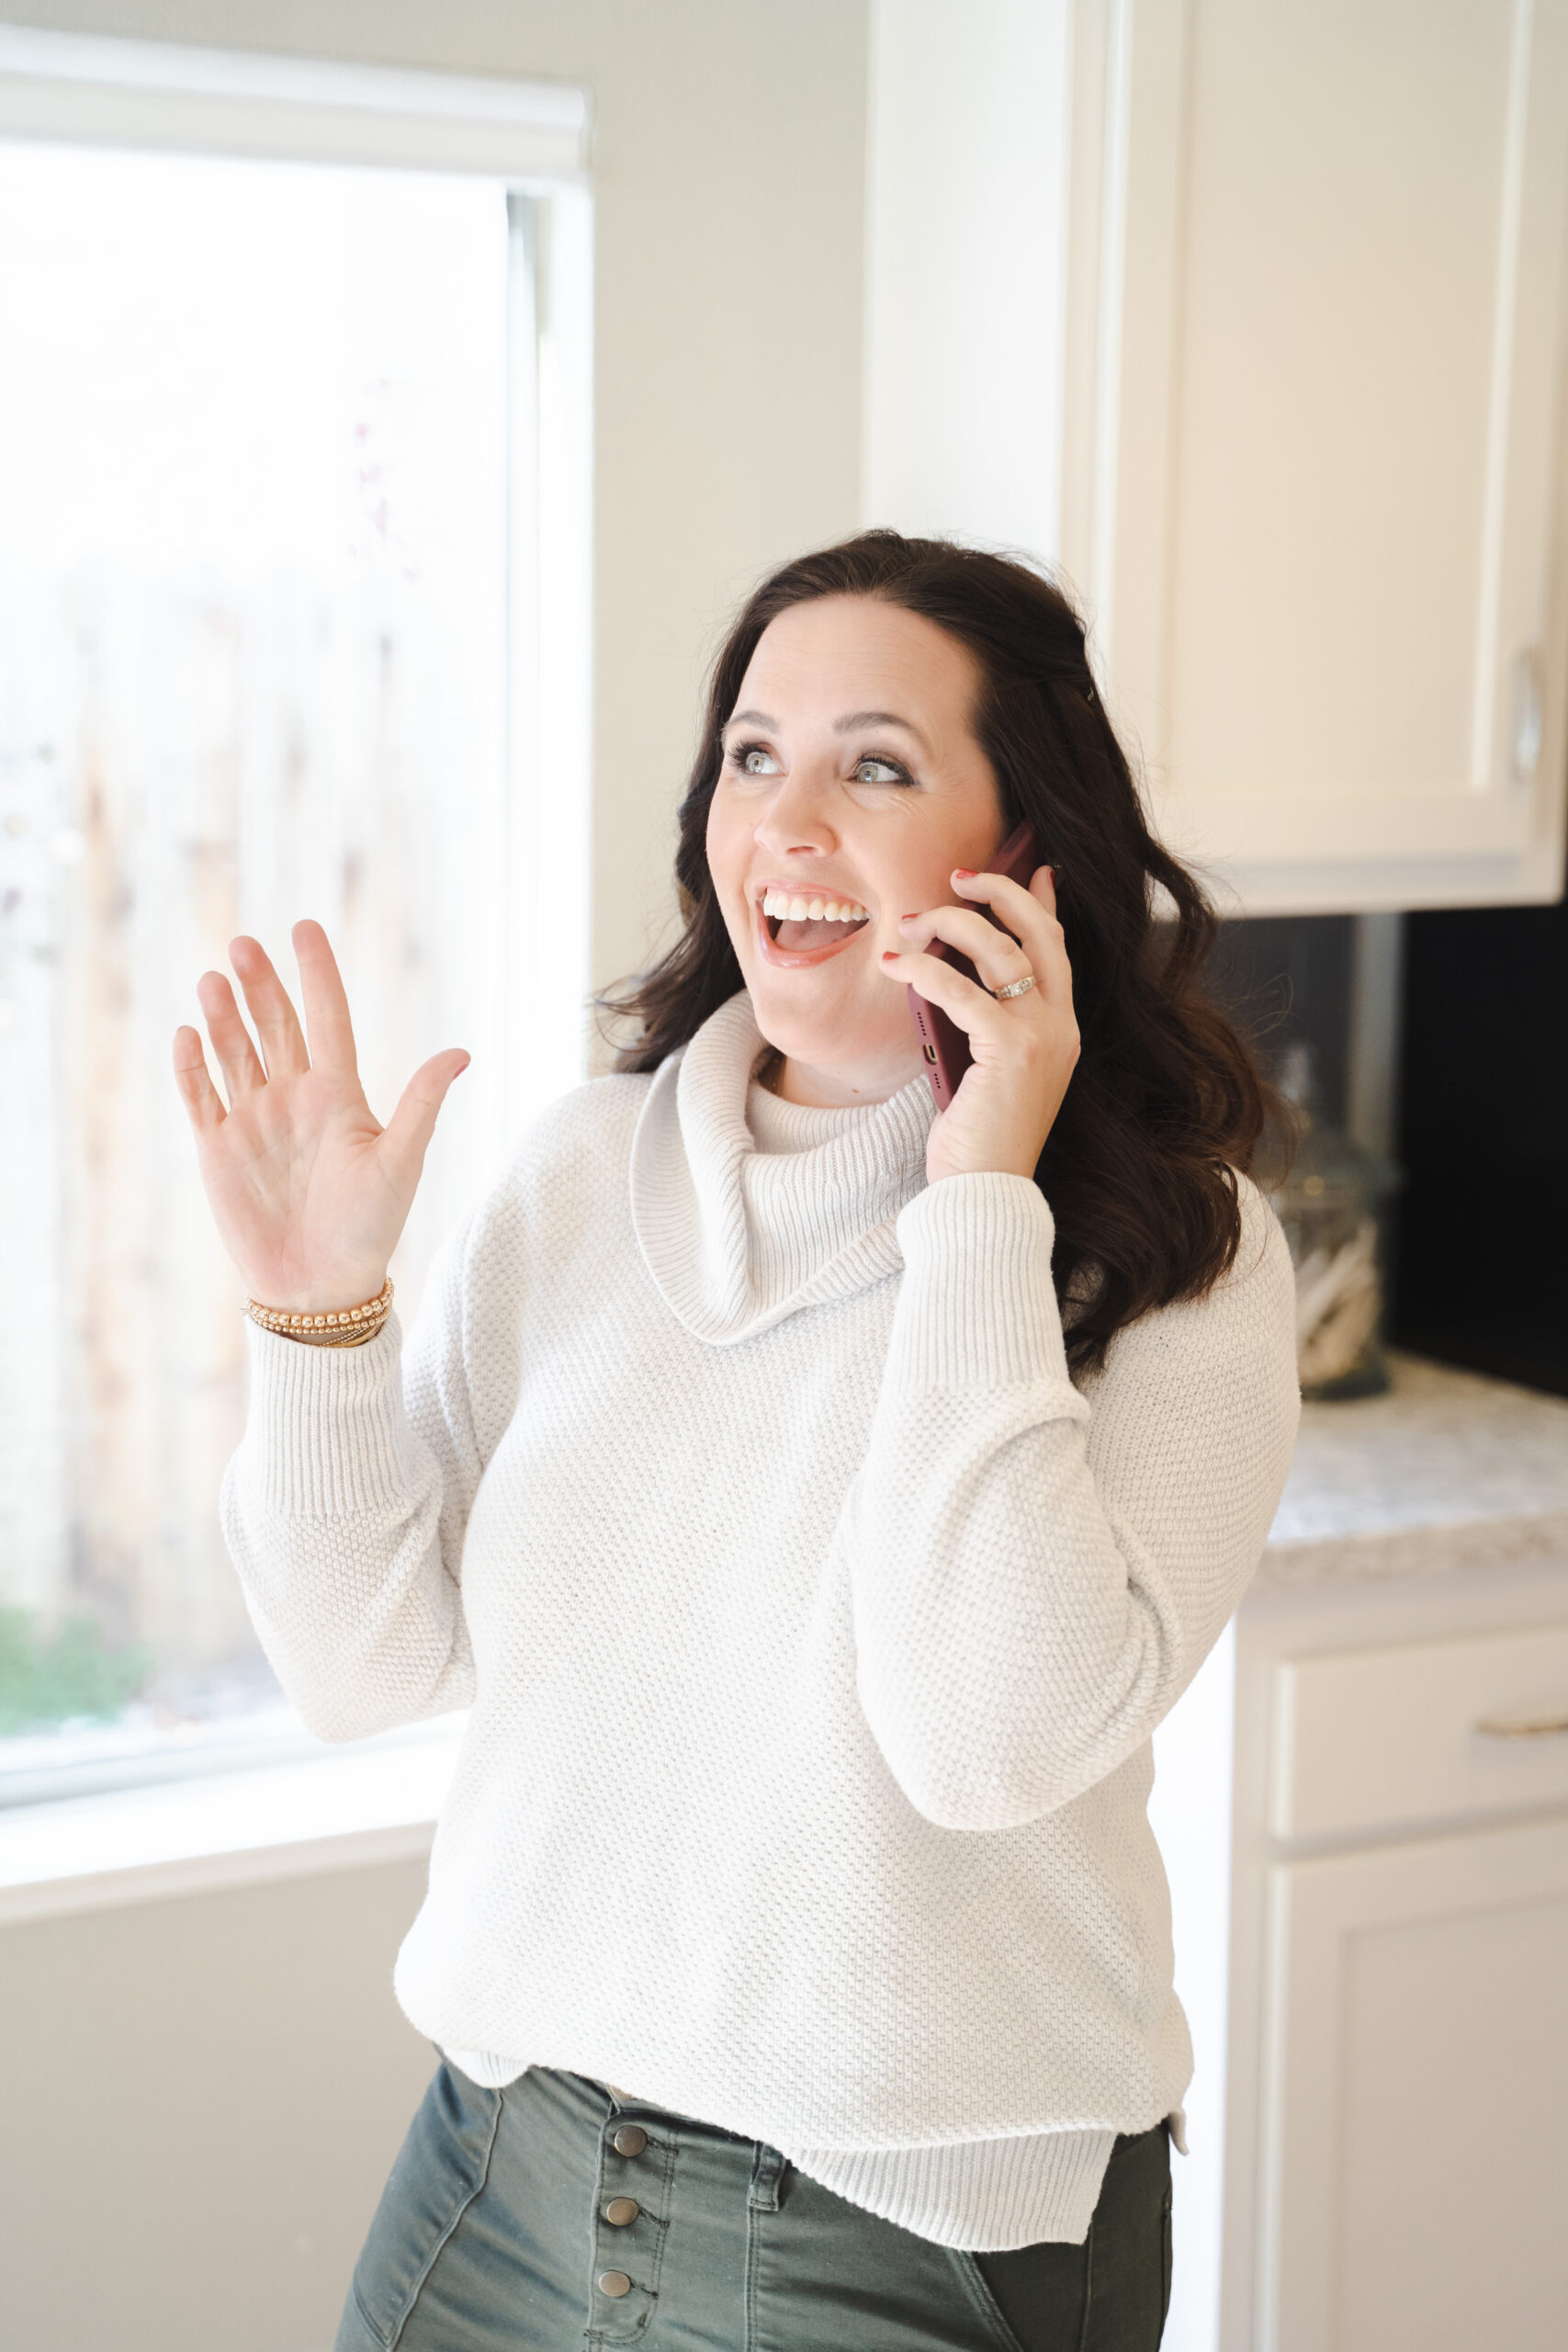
219 1227 482 1740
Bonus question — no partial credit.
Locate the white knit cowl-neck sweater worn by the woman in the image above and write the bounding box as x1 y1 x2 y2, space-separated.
223 995 1298 2251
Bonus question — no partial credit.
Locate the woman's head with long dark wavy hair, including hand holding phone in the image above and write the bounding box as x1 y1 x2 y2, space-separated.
604 532 1267 1369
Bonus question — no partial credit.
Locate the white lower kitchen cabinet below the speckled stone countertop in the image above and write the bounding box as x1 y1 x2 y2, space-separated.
1149 1552 1568 2352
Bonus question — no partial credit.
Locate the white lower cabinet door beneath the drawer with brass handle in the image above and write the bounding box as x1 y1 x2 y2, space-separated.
1256 1818 1568 2352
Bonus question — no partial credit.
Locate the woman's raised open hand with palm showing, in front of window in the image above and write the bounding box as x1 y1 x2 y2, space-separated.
174 922 468 1315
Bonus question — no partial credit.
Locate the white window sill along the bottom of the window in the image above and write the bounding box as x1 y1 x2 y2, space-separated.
0 1729 461 1927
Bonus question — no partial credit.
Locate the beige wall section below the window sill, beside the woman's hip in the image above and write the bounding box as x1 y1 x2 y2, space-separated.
0 1863 434 2352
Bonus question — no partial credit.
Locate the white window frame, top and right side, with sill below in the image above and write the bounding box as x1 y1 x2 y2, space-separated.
0 26 592 1853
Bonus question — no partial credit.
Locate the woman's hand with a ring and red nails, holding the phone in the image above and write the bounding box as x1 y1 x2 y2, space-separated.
882 865 1079 1183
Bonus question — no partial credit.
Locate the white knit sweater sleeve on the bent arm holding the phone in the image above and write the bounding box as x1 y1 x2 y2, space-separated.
846 1173 1300 1830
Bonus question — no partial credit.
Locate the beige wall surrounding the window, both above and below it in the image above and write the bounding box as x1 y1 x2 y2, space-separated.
0 0 865 2352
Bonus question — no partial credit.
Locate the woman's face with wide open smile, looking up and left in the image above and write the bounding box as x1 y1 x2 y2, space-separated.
707 595 1001 1103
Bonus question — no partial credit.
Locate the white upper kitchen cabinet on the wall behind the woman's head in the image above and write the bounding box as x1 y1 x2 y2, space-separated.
865 0 1568 912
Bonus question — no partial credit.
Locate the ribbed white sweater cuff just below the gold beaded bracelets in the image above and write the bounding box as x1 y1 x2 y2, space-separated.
243 1315 412 1520
